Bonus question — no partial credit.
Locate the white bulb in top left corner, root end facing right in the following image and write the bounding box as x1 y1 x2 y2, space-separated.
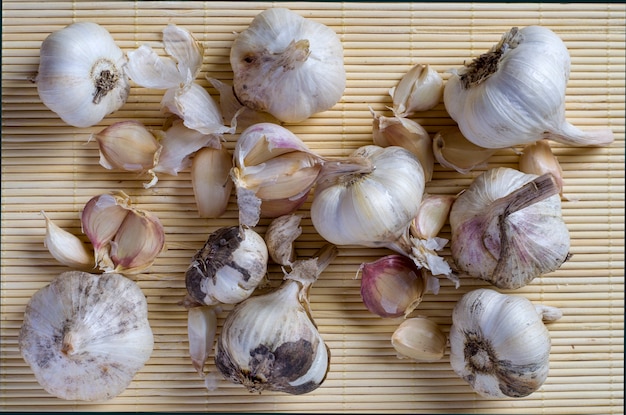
35 22 130 127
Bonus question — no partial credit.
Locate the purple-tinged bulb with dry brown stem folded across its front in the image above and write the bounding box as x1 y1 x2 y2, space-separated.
450 167 570 289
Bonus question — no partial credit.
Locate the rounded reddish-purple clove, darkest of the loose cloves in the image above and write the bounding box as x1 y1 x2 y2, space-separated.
359 255 426 318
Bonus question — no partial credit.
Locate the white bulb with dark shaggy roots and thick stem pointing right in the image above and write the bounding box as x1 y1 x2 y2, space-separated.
444 26 613 148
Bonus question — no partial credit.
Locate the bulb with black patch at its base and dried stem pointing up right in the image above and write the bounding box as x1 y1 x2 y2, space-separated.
215 245 337 395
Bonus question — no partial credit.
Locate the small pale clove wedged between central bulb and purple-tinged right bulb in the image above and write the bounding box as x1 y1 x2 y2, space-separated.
410 194 456 239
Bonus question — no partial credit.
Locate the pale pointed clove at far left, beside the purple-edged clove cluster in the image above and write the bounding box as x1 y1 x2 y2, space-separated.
41 210 95 270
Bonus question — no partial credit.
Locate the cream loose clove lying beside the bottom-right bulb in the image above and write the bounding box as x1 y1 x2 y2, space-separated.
391 317 447 362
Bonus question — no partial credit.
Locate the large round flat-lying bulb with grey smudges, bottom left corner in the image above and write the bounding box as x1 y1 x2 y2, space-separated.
19 271 154 401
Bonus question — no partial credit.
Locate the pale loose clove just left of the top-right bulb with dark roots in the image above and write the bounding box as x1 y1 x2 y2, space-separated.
389 64 443 117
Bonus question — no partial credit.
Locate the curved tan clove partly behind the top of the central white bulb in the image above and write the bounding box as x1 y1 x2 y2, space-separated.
370 108 435 182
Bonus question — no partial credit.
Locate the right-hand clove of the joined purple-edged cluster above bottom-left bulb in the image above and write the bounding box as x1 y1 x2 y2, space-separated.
110 209 165 274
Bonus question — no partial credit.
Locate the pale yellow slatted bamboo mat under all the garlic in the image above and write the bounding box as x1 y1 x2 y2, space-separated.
0 1 626 414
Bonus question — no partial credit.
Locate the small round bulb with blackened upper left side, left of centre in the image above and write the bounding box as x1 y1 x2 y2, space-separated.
185 226 269 305
